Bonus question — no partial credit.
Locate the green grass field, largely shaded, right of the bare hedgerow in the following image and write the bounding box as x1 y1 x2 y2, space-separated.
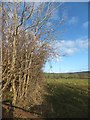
45 78 88 118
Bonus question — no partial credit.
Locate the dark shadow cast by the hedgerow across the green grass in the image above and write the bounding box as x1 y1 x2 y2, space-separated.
42 81 88 118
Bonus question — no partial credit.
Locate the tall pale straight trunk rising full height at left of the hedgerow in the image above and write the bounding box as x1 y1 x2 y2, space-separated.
12 3 17 105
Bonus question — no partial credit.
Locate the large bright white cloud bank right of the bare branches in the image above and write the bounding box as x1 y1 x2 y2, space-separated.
54 38 88 55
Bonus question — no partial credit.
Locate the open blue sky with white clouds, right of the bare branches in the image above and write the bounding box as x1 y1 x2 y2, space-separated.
44 2 88 73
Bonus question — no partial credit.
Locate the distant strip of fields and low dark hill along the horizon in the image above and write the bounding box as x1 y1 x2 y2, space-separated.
44 71 90 79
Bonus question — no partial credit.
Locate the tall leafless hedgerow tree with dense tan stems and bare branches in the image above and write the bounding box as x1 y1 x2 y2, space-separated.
1 2 63 107
